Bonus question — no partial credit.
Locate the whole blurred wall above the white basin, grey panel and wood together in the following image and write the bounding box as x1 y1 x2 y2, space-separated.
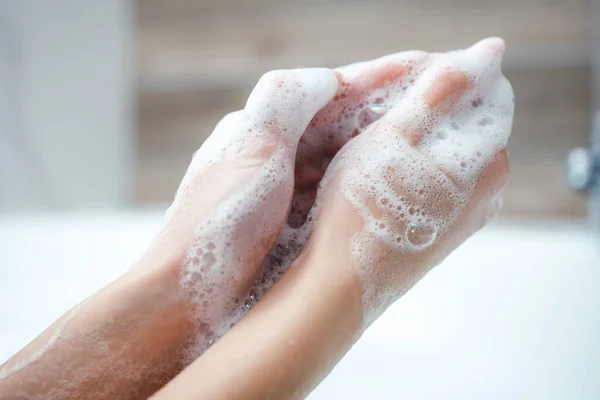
0 0 594 217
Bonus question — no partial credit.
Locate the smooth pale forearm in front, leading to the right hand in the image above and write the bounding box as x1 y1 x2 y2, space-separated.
150 216 364 399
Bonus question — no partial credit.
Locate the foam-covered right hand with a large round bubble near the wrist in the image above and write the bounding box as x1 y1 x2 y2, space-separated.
315 39 513 323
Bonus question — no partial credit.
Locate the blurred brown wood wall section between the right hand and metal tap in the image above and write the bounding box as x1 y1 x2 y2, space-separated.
505 68 591 216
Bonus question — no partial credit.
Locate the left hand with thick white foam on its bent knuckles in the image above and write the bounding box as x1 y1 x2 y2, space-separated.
138 68 338 358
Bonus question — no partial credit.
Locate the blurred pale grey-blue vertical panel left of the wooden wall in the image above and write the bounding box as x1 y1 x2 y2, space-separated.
0 0 135 211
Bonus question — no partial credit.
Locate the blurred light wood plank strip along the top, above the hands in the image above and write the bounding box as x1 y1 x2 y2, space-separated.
138 0 589 90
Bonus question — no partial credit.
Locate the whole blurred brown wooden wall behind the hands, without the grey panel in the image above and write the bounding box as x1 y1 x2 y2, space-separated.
137 0 591 215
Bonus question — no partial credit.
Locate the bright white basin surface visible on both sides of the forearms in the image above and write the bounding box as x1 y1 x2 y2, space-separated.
0 211 600 400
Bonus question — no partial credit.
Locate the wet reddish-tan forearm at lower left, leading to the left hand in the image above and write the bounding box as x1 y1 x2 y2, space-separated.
0 264 190 399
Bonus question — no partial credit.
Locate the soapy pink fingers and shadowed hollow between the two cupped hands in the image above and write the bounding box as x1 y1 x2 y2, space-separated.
289 51 428 227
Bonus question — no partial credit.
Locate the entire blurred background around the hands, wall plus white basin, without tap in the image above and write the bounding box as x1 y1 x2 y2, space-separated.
0 0 600 400
